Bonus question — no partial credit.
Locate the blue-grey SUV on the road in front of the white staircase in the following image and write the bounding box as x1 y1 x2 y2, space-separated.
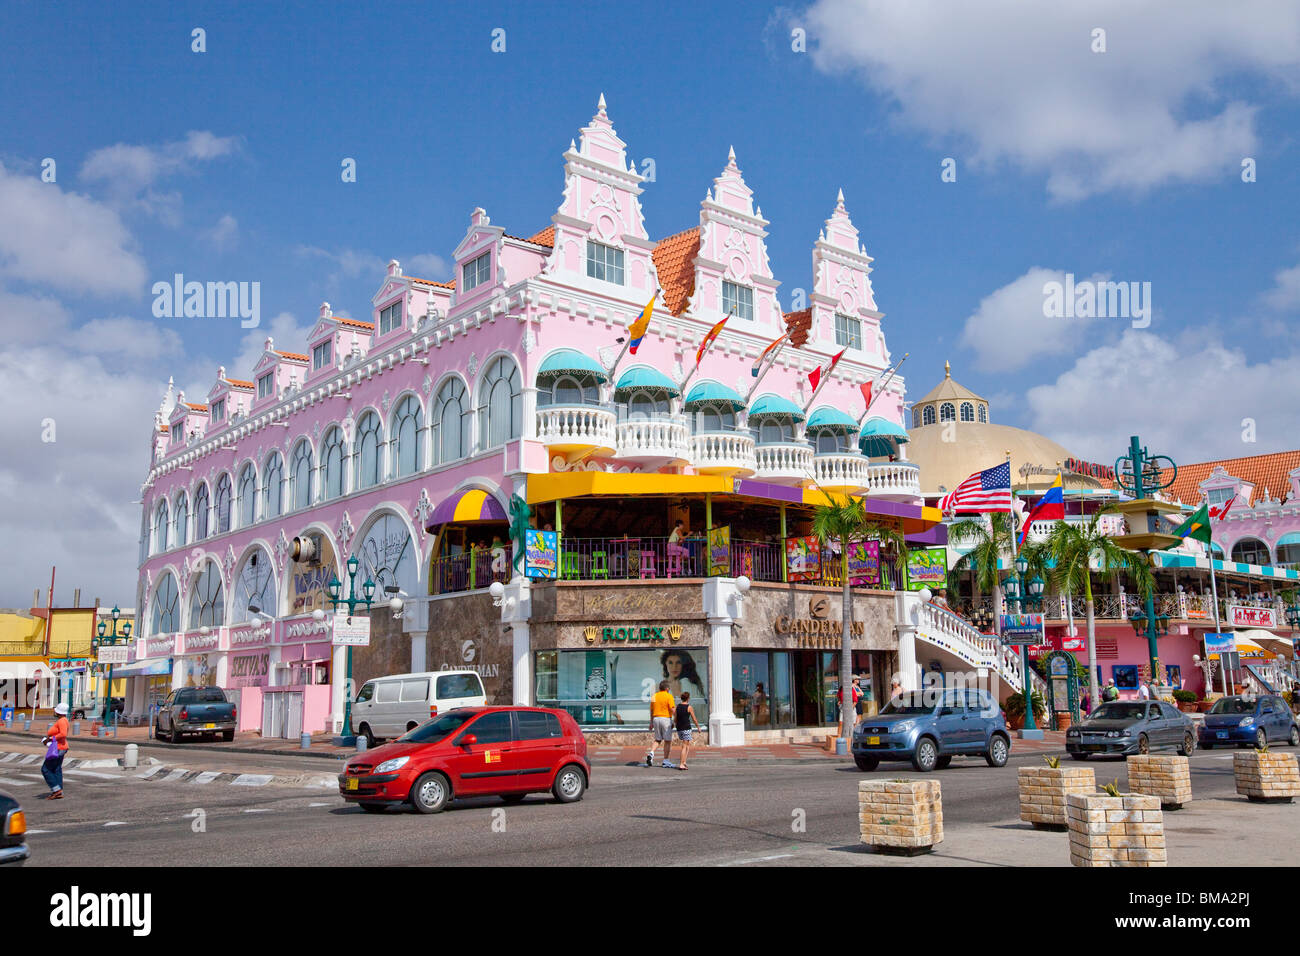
853 689 1011 773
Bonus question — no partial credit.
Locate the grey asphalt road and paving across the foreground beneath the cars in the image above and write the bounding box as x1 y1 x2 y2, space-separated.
0 748 1300 866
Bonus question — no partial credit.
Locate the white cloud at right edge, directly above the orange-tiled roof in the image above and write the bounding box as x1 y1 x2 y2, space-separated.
1024 329 1300 462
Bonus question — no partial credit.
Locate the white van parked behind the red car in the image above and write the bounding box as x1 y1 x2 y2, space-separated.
352 671 488 747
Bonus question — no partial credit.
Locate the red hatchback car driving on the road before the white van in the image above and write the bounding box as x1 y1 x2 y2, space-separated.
338 708 592 813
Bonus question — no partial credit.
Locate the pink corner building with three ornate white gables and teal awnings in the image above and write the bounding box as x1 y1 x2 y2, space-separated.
127 98 939 735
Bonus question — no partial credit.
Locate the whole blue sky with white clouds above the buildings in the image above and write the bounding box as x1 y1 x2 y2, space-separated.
0 0 1300 601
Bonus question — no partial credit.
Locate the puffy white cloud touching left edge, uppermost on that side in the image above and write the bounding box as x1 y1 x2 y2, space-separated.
0 166 146 299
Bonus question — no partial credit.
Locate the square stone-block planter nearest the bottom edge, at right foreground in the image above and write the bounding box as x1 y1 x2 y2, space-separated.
1066 793 1167 866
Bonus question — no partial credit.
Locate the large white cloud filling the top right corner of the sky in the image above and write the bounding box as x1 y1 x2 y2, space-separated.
789 0 1300 200
